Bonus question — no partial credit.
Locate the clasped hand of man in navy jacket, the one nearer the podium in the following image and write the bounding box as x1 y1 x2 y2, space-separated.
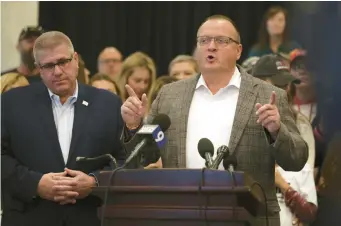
54 168 96 205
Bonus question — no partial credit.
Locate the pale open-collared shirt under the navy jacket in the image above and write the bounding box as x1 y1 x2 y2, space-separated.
48 83 78 164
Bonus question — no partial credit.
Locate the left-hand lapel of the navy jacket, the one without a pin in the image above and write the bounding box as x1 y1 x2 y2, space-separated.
35 83 65 166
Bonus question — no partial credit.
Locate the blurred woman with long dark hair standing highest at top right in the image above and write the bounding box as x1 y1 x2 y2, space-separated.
248 6 301 57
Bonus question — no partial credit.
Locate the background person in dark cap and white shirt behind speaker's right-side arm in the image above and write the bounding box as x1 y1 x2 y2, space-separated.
253 54 317 226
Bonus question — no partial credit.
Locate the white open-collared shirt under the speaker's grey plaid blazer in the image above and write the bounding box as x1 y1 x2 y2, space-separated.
186 67 241 169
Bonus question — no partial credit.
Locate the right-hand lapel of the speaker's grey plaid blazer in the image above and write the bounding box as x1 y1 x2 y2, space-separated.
229 67 258 154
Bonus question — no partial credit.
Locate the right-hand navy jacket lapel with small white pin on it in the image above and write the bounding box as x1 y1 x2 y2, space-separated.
67 83 91 163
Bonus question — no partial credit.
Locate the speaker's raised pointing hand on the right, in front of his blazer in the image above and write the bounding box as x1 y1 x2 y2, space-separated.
256 91 281 138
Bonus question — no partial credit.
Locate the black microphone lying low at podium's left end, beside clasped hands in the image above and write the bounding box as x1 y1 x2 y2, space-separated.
75 154 117 173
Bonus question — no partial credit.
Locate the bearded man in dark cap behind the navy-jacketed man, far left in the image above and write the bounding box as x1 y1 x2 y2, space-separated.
1 26 44 83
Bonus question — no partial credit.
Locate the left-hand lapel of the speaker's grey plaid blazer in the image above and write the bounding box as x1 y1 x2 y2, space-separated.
177 74 200 168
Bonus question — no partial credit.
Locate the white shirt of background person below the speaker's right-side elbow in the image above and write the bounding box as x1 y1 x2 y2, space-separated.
277 164 317 226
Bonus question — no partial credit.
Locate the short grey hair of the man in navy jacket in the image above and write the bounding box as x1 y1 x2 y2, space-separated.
33 31 75 62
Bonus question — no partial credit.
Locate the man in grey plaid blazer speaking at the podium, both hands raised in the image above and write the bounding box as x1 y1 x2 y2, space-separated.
121 16 308 226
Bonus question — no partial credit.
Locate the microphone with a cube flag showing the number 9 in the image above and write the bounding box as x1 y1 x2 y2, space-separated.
124 114 171 166
